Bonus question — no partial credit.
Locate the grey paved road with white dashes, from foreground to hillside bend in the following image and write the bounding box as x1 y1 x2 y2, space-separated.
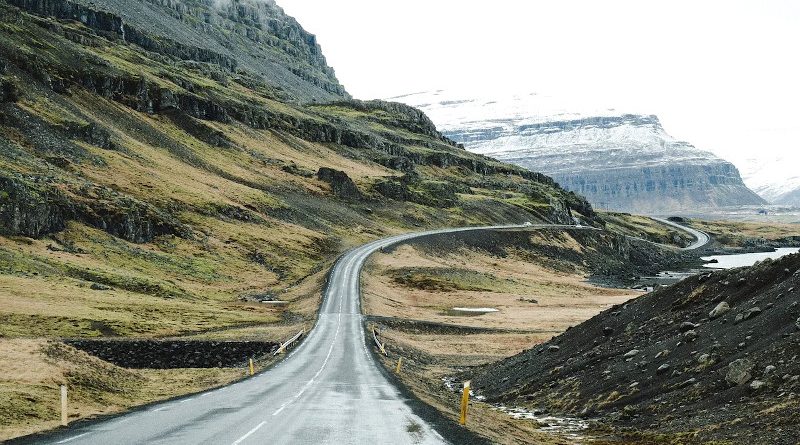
32 225 588 445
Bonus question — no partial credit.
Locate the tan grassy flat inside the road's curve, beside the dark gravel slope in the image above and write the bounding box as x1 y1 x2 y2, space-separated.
363 230 638 444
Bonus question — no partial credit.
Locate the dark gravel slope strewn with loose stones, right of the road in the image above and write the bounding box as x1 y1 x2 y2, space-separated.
468 251 800 444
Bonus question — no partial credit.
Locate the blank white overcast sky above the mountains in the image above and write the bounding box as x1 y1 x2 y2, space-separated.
277 0 800 161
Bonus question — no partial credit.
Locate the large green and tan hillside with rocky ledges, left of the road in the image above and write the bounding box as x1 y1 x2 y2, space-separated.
0 0 594 336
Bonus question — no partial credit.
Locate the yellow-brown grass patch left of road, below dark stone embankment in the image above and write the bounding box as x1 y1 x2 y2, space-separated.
0 339 243 437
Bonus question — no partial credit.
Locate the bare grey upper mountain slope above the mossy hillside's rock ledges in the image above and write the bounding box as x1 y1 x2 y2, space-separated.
9 0 349 102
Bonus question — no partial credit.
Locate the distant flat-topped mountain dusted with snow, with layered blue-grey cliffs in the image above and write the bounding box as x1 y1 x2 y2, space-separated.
391 91 765 213
